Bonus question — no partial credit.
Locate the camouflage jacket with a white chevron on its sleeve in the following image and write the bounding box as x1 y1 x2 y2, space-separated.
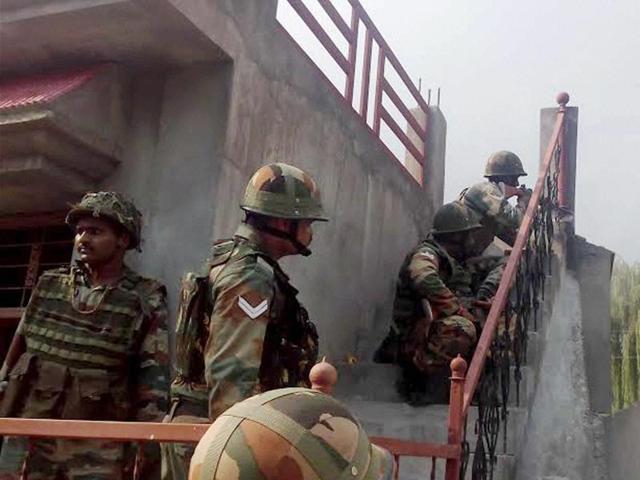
172 224 318 420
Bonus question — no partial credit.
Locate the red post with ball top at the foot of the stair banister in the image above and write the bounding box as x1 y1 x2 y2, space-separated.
444 355 467 480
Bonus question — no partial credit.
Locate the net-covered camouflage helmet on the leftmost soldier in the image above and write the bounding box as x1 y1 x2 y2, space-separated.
66 192 142 249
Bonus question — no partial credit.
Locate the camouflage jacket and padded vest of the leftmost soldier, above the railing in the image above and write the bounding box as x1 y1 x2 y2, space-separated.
0 266 169 421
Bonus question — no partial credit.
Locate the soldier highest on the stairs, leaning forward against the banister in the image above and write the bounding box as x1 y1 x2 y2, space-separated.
459 151 531 246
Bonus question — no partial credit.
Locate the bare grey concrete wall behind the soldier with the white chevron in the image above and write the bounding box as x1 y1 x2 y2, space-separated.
104 0 442 361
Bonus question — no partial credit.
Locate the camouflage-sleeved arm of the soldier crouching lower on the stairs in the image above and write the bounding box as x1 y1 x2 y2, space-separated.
409 250 473 318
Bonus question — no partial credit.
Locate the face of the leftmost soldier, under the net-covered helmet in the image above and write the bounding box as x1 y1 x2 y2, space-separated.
75 217 129 266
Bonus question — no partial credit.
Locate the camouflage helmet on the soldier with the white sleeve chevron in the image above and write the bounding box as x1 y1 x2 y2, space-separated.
240 163 328 221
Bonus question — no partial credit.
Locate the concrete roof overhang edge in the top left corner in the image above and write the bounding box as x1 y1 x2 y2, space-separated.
0 0 225 76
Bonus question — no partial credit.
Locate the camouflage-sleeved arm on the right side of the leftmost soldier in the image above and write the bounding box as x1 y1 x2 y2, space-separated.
132 287 170 422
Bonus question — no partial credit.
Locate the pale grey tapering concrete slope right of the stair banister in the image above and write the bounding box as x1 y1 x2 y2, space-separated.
516 272 607 480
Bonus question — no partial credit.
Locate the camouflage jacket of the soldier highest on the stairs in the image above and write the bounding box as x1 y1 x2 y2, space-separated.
459 181 524 245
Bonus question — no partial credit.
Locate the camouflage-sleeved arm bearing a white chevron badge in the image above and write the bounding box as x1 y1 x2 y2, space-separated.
204 267 273 420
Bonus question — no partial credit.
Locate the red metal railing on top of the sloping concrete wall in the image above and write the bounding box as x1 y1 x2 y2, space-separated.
278 0 429 184
